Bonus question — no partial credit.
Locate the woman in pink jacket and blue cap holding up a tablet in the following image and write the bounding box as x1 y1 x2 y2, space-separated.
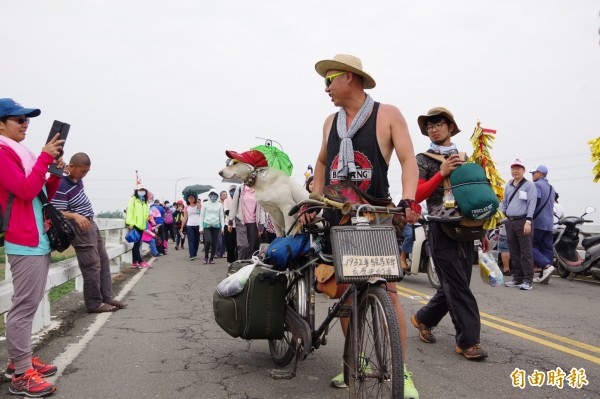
0 98 65 397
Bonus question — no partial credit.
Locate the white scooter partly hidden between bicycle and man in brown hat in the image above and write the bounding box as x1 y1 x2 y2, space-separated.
399 218 440 288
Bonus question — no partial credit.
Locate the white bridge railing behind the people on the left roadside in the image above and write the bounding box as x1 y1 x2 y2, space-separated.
0 219 147 334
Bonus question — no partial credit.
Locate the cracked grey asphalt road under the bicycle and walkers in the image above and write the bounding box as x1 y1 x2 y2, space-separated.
0 250 600 399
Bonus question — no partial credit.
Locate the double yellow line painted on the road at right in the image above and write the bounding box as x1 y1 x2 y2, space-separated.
396 286 600 364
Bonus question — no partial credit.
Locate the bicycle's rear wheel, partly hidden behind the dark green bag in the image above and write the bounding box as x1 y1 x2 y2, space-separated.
269 278 308 367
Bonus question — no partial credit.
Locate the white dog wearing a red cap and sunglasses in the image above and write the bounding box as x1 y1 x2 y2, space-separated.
219 150 308 237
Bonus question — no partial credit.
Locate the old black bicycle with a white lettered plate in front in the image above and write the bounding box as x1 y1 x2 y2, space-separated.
263 198 404 398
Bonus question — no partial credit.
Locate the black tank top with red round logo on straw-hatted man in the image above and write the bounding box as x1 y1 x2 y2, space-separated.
325 102 390 198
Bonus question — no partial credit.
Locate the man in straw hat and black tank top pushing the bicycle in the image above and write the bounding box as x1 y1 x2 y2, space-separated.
313 54 420 398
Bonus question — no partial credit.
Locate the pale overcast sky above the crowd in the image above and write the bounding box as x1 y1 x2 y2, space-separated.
0 0 600 221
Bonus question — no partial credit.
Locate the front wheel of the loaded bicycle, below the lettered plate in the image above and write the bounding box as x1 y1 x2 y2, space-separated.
344 286 404 399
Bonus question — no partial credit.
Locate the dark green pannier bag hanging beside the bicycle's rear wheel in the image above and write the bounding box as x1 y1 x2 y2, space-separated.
213 266 287 339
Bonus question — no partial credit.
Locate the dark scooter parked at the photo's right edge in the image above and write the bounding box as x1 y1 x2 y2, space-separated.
554 206 600 280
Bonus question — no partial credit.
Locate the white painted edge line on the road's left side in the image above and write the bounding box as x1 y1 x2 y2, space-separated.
46 258 154 384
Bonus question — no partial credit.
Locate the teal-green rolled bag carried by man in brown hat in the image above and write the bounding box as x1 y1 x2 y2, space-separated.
450 163 500 221
